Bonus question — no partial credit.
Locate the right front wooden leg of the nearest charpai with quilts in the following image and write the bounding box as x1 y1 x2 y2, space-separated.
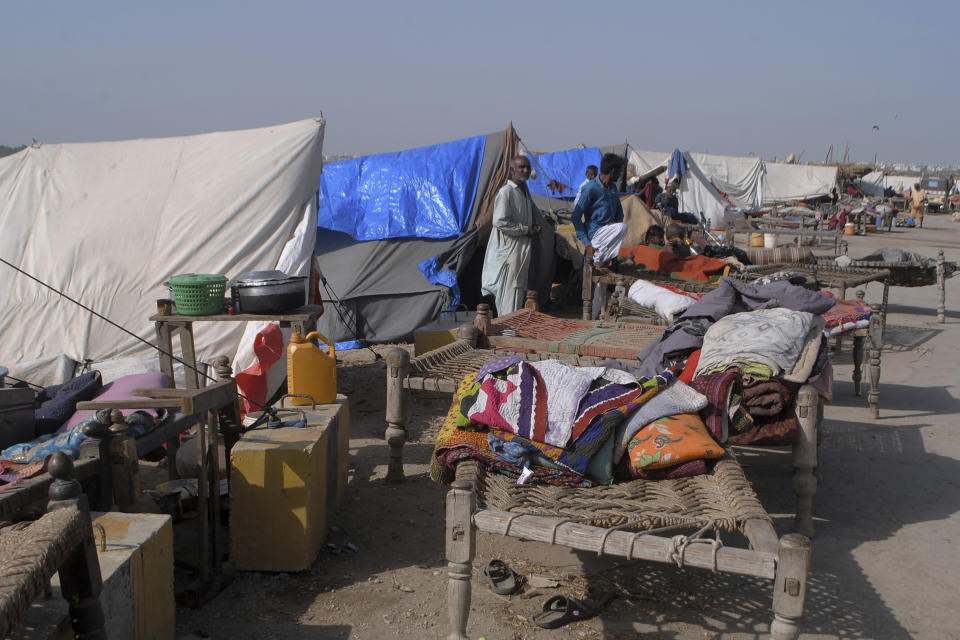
770 533 810 640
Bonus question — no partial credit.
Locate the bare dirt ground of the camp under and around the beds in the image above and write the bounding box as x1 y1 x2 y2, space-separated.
177 216 960 640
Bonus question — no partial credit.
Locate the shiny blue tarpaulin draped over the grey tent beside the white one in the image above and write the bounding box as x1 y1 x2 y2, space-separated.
317 136 487 241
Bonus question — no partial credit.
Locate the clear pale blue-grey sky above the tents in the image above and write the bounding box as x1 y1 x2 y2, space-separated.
0 0 960 164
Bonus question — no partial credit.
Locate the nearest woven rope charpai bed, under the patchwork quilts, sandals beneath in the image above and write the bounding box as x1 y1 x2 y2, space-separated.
445 378 810 640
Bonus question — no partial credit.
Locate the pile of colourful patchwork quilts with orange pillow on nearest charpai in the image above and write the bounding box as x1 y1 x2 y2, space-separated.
430 356 723 486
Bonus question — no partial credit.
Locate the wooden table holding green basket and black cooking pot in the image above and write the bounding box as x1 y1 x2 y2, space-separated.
150 305 323 389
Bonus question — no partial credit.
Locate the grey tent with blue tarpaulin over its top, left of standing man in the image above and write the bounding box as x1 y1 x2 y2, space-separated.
316 127 518 342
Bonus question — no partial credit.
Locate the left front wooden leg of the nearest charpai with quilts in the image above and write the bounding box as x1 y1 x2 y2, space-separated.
445 480 477 640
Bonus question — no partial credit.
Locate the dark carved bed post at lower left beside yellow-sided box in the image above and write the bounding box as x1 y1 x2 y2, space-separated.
47 451 107 640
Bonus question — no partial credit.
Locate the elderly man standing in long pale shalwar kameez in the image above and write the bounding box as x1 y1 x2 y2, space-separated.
480 156 540 316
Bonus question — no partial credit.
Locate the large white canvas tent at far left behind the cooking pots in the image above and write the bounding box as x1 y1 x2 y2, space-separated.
0 119 324 384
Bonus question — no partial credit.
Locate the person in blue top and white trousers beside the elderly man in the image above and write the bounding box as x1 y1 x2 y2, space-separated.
570 153 627 318
